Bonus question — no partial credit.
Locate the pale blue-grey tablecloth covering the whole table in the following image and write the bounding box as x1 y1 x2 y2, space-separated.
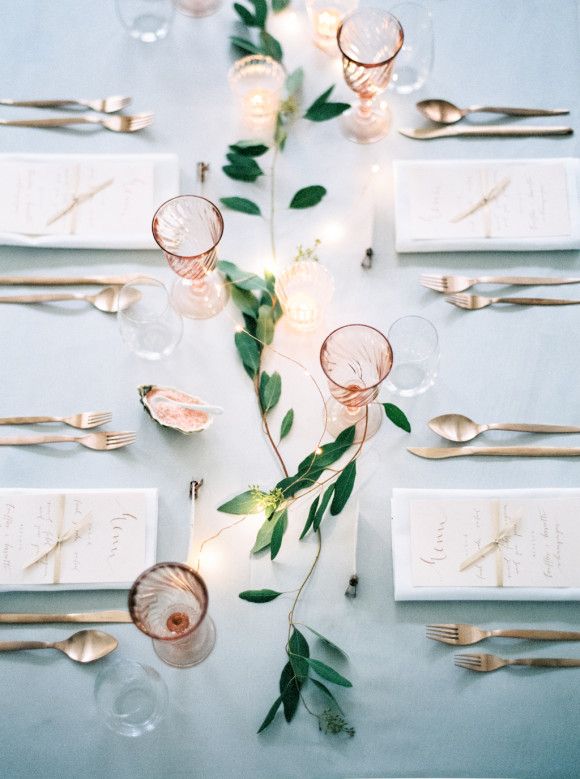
0 0 580 779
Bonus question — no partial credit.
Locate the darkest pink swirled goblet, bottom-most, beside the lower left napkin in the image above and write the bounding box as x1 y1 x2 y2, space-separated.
129 563 215 668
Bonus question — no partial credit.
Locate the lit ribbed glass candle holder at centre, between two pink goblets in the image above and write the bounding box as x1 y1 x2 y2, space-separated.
276 260 334 333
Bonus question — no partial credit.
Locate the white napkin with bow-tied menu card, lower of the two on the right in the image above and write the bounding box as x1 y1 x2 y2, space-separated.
392 489 580 600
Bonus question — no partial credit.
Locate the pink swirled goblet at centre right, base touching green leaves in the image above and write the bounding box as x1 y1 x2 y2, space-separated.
320 325 393 440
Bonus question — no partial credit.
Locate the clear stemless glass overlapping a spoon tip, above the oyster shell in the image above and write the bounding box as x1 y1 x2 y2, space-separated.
117 277 183 360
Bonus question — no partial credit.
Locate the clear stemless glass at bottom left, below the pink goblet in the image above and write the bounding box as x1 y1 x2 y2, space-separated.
95 658 169 738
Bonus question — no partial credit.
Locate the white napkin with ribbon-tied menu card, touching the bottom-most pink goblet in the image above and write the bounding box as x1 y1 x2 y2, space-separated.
0 489 157 590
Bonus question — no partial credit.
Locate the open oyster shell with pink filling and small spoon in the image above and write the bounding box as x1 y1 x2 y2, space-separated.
137 384 213 435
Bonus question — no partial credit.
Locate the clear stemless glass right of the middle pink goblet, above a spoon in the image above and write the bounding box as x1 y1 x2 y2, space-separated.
385 316 439 398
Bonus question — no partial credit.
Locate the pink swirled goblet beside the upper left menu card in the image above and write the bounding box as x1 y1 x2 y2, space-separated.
152 195 228 319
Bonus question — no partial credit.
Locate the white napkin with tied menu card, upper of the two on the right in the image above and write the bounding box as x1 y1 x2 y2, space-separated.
395 159 580 252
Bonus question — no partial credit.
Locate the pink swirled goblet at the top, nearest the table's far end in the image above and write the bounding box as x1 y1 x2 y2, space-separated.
337 8 404 143
